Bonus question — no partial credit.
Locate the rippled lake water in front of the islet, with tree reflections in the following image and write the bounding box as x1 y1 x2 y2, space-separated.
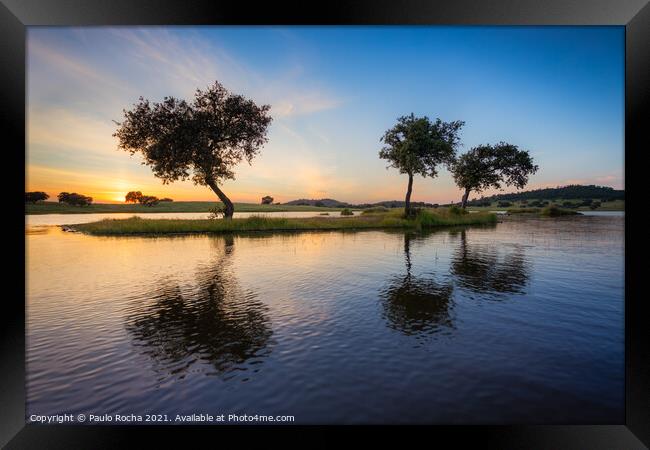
26 216 624 423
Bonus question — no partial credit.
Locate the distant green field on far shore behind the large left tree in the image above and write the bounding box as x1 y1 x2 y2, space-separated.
25 202 343 214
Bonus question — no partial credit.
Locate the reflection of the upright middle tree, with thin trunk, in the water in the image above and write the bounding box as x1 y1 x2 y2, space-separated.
380 233 453 338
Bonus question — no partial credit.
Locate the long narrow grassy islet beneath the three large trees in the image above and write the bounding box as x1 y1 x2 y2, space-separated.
70 208 497 236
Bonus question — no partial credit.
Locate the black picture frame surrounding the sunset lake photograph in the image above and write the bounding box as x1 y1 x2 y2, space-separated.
0 0 650 449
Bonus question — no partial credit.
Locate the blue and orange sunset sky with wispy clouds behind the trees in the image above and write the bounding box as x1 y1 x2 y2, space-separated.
26 26 624 203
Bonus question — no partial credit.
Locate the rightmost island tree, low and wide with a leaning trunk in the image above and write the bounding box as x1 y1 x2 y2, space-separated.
452 142 538 208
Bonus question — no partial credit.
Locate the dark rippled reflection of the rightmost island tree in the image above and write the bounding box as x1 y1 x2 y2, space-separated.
451 230 531 294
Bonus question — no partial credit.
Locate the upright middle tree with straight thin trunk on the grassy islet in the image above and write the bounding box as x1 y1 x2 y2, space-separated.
379 113 465 217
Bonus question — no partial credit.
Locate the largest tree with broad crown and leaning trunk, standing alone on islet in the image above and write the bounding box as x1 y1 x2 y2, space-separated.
114 82 272 219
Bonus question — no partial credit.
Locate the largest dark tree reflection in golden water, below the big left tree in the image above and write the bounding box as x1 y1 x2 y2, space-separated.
126 236 272 381
